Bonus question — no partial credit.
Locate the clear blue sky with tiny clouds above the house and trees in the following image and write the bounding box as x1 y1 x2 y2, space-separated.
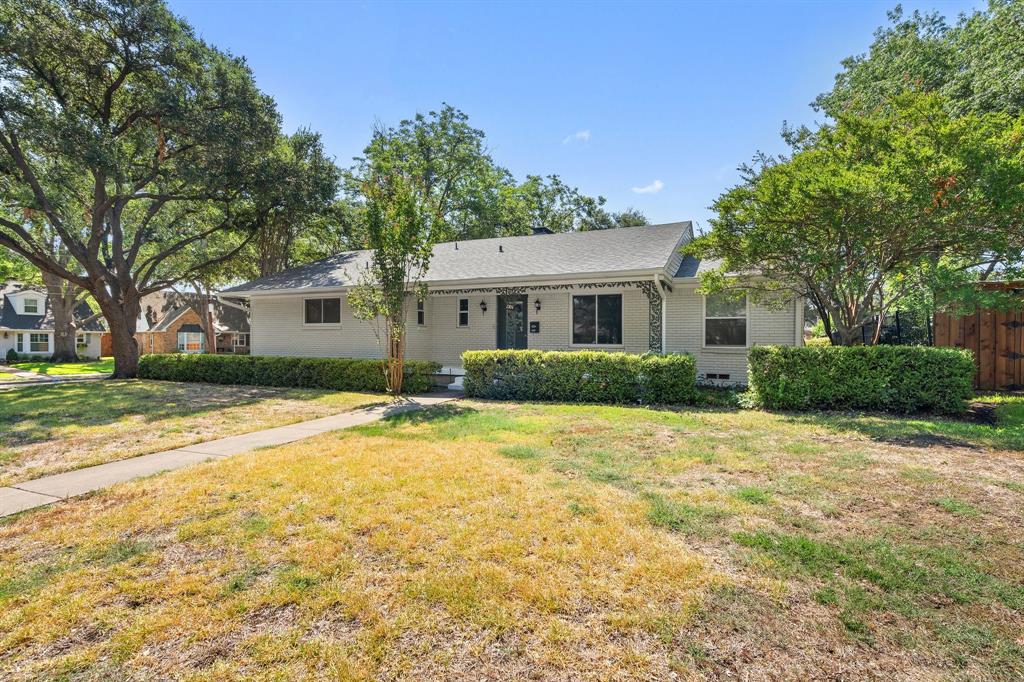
170 0 981 231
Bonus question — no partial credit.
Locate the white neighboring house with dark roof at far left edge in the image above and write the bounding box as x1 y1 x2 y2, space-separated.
0 282 103 358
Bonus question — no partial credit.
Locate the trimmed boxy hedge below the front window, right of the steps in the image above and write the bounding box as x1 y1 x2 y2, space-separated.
462 350 696 404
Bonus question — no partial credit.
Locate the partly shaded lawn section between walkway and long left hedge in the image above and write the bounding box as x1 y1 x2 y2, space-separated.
0 381 385 485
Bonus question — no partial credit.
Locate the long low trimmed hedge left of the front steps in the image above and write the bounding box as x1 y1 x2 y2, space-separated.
138 353 440 393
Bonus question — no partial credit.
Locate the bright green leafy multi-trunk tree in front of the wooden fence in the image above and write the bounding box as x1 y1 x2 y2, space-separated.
690 94 1024 343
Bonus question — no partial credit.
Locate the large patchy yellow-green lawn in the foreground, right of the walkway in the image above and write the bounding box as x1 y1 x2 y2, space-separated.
0 401 1024 680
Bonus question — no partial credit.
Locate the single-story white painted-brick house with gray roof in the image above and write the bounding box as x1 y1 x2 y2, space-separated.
223 222 804 384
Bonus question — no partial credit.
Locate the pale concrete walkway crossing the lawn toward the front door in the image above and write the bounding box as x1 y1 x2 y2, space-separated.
0 391 461 516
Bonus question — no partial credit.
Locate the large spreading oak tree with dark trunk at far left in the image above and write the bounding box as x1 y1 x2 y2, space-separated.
0 0 280 377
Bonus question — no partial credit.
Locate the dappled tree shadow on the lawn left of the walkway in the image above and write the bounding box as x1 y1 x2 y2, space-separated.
0 380 337 446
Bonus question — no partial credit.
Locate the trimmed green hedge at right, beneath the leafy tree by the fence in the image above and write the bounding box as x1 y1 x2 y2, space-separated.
749 346 975 414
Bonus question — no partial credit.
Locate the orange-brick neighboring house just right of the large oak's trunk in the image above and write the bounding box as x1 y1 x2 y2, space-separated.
106 291 249 355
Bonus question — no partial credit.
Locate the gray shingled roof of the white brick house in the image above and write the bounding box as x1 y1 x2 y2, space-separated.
225 221 690 293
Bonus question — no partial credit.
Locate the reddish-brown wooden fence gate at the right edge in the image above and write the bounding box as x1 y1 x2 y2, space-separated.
935 289 1024 391
